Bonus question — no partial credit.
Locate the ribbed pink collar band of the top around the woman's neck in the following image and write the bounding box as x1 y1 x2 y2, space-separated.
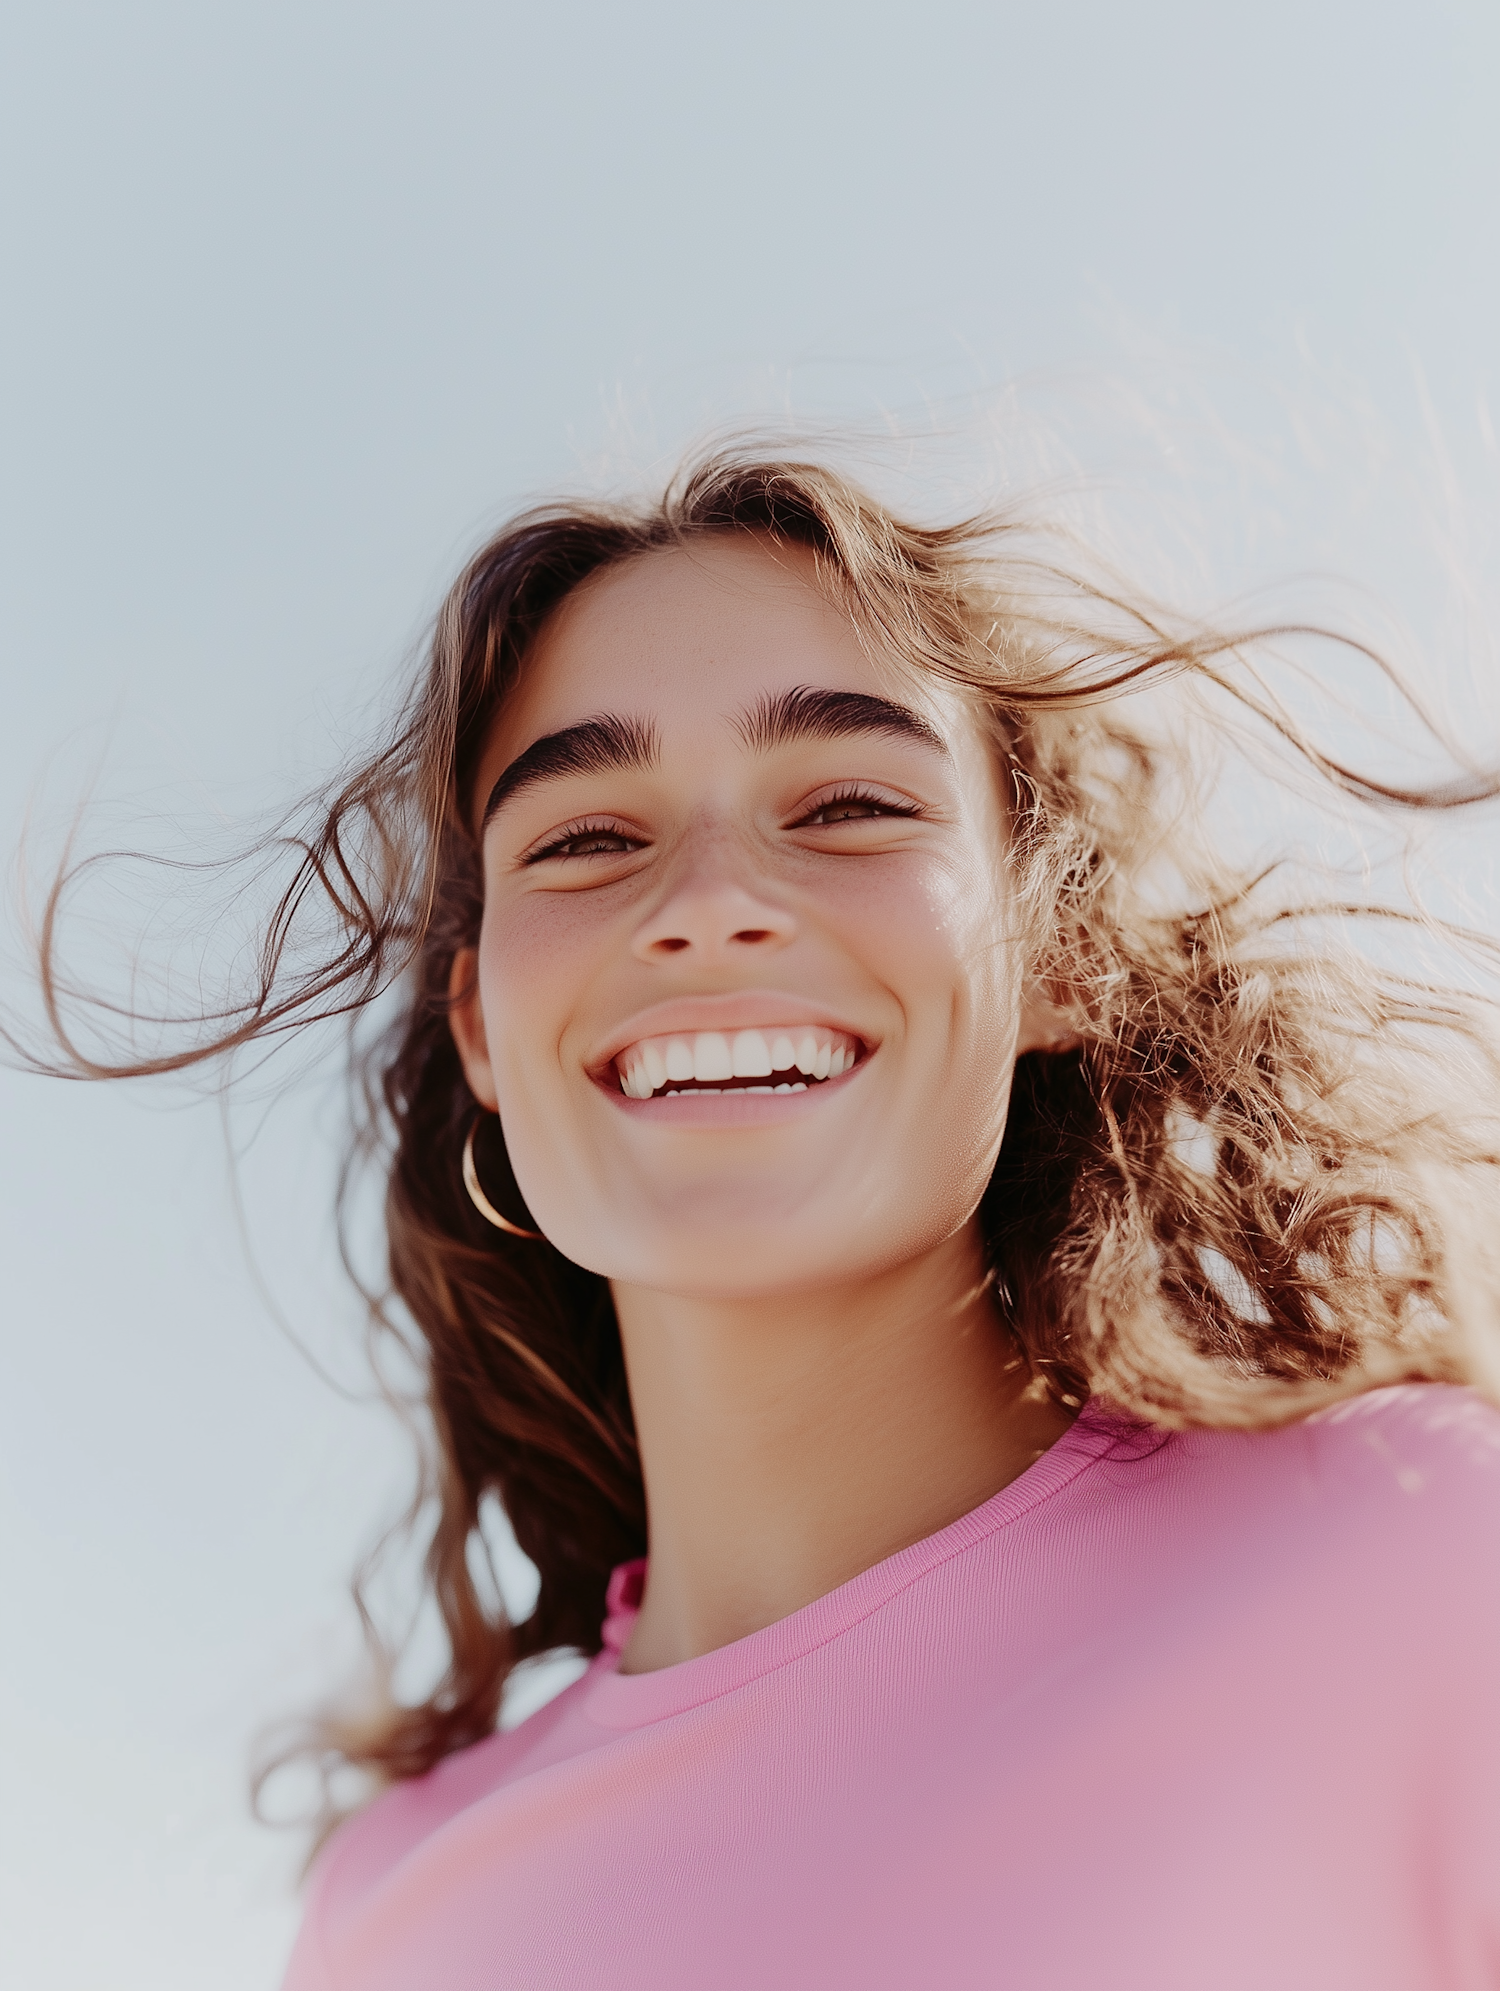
580 1398 1131 1728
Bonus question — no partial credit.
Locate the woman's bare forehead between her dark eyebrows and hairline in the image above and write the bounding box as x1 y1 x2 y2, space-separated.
484 534 948 765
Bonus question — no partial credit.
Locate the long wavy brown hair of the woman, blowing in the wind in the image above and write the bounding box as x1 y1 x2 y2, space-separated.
23 450 1496 1823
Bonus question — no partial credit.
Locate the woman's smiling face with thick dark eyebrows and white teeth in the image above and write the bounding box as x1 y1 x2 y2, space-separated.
454 534 1048 1298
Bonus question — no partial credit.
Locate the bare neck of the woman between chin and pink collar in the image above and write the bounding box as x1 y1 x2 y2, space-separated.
614 1226 1070 1672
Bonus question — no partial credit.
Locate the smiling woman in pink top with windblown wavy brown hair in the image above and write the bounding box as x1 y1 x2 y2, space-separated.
38 452 1500 1991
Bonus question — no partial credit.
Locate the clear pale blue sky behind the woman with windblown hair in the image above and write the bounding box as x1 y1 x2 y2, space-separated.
0 0 1500 1991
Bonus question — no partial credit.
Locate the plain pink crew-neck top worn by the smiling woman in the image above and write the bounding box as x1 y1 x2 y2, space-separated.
287 1386 1500 1991
